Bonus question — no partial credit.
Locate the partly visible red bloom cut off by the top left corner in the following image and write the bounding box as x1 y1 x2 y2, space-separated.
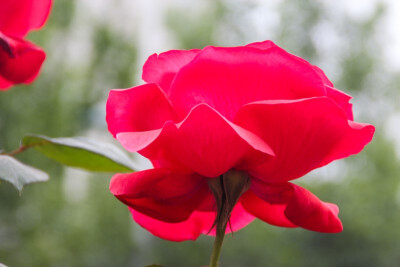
0 0 52 90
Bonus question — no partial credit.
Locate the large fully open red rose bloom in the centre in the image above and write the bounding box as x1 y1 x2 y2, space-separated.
106 41 374 241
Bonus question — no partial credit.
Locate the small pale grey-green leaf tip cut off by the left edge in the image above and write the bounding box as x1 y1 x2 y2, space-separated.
0 155 49 193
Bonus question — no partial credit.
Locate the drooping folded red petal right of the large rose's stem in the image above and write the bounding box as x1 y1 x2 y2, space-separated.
242 179 343 233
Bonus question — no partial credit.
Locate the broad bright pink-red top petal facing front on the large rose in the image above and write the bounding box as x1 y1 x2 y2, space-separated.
170 47 326 120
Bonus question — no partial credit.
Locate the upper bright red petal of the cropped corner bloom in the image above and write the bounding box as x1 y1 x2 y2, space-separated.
0 0 52 37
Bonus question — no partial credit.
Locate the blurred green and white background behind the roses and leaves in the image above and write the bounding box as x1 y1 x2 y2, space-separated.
0 0 400 267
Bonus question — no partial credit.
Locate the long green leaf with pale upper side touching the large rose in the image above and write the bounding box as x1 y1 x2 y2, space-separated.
22 135 136 172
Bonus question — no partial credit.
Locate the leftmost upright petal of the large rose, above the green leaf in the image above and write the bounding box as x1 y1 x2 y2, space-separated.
106 84 175 137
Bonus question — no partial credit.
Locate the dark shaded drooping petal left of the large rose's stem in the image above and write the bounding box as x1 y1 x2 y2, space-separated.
110 169 209 223
